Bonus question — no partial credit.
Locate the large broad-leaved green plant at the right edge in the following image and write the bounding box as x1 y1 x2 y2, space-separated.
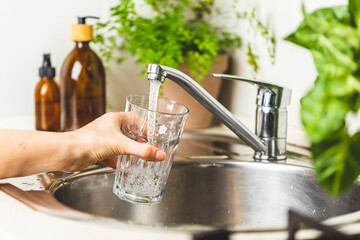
286 0 360 195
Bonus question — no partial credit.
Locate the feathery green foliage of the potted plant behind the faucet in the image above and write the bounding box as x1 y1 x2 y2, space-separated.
94 0 275 81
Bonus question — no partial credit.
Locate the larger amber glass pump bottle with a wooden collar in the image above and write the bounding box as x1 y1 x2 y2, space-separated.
60 17 105 131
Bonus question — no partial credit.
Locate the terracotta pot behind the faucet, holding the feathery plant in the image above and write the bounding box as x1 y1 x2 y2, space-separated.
162 54 229 130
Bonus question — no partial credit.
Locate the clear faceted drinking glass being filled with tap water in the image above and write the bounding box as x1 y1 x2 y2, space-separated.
113 95 189 205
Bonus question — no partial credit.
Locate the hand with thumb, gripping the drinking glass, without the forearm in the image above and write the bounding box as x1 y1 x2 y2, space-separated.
66 112 166 171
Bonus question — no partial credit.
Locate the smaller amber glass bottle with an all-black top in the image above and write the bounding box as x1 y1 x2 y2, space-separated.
35 54 60 131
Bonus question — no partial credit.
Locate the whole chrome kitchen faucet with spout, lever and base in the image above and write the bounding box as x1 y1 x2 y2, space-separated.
147 64 291 161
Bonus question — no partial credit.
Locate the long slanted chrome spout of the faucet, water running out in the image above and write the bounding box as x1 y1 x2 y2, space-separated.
148 64 267 153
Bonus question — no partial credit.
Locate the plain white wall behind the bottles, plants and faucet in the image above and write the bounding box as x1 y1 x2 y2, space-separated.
0 0 347 142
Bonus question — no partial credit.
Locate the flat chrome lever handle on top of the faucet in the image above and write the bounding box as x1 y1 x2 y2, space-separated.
211 73 291 108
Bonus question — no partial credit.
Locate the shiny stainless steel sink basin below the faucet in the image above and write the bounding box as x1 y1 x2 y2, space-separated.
50 134 360 229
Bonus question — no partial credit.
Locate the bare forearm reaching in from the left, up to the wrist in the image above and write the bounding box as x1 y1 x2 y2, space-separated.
0 129 81 179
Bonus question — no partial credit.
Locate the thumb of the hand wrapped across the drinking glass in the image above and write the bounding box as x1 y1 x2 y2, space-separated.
120 136 166 161
